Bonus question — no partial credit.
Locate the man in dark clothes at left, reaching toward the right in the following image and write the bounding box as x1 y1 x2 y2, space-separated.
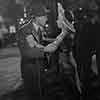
17 5 52 100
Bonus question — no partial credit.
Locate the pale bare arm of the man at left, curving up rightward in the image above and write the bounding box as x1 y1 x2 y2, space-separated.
26 26 68 53
